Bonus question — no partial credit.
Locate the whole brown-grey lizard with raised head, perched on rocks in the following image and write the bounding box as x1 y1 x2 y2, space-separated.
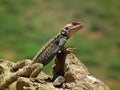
0 22 83 90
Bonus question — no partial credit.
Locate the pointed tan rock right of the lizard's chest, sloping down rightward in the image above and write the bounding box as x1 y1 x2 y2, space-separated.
64 53 110 90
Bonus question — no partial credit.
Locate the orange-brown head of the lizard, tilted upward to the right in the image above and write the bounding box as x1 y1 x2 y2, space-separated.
61 22 83 38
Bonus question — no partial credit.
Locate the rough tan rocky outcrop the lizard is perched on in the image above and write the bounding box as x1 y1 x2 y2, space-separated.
0 53 110 90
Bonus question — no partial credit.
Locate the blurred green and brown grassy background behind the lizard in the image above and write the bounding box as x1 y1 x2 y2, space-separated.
0 0 120 90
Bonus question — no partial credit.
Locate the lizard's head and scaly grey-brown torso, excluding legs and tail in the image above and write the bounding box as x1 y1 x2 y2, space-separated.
32 22 83 66
